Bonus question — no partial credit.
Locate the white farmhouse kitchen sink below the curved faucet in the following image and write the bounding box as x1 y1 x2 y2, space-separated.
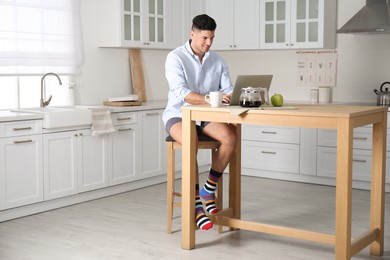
12 106 92 128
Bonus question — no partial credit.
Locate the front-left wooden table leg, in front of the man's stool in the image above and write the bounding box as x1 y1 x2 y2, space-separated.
181 110 197 249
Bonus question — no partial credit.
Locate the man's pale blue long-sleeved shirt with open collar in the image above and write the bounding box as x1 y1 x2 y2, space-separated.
162 41 233 128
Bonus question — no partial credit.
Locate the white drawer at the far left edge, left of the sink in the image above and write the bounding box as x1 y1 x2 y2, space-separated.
0 120 42 137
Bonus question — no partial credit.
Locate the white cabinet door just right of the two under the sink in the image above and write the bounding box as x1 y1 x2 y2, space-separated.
108 124 139 185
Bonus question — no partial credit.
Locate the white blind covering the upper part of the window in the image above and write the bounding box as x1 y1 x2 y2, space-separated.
0 0 83 75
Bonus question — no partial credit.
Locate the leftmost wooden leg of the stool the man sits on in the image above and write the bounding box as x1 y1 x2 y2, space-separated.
167 142 175 234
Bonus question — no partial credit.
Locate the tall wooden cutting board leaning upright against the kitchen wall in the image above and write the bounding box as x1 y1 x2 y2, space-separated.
129 49 146 101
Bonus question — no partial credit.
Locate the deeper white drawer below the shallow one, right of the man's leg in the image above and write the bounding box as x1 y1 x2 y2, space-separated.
241 141 299 173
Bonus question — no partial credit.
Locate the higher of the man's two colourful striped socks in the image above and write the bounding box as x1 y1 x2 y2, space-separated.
200 169 222 214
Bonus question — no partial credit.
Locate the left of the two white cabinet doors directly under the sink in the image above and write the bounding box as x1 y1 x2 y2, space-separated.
43 131 79 200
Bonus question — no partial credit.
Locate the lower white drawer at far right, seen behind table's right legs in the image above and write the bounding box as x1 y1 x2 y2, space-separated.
317 147 390 181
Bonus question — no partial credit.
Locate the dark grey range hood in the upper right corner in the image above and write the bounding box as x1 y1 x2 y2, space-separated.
337 0 390 33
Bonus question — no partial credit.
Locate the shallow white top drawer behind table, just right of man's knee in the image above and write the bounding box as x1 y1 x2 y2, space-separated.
242 125 300 144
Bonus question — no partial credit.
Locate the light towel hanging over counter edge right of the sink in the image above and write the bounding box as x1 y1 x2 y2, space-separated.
91 108 115 135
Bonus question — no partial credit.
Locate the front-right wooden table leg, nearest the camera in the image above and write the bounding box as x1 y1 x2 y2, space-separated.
335 119 353 260
